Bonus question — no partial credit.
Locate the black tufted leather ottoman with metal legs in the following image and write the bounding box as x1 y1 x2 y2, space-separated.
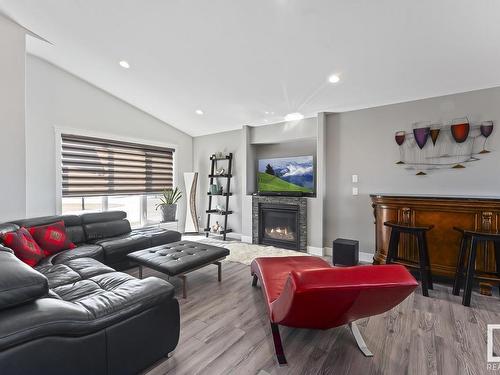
128 241 229 298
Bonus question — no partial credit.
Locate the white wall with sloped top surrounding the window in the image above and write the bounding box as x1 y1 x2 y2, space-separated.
23 55 193 226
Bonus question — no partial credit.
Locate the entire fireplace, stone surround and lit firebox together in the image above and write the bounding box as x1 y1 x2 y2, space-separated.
252 196 307 251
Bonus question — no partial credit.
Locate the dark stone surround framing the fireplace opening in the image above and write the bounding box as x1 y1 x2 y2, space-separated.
252 195 307 252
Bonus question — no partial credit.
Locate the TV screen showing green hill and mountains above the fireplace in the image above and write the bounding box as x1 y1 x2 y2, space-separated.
258 156 314 193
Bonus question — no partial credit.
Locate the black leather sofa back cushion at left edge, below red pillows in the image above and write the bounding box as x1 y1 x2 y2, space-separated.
0 251 48 310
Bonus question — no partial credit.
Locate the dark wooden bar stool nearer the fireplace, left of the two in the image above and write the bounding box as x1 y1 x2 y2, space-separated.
384 221 434 297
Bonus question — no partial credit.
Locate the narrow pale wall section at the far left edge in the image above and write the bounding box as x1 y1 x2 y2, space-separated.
0 16 26 222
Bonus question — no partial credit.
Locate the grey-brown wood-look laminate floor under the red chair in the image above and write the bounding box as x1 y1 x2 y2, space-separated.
130 262 500 375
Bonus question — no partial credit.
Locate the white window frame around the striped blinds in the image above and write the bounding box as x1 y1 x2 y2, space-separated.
54 126 179 226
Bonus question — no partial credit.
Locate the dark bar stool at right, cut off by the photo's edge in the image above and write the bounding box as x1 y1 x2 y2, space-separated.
452 227 500 306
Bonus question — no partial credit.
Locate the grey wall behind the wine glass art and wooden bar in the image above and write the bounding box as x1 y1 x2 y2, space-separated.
324 88 500 252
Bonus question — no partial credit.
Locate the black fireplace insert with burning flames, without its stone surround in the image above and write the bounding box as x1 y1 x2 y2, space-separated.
259 204 299 250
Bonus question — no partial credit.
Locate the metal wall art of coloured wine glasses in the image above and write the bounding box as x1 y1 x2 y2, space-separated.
394 117 493 176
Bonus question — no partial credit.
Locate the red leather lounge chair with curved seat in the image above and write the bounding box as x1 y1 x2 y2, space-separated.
251 256 418 364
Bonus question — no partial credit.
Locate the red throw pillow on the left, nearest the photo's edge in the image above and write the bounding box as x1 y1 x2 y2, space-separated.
2 228 45 267
